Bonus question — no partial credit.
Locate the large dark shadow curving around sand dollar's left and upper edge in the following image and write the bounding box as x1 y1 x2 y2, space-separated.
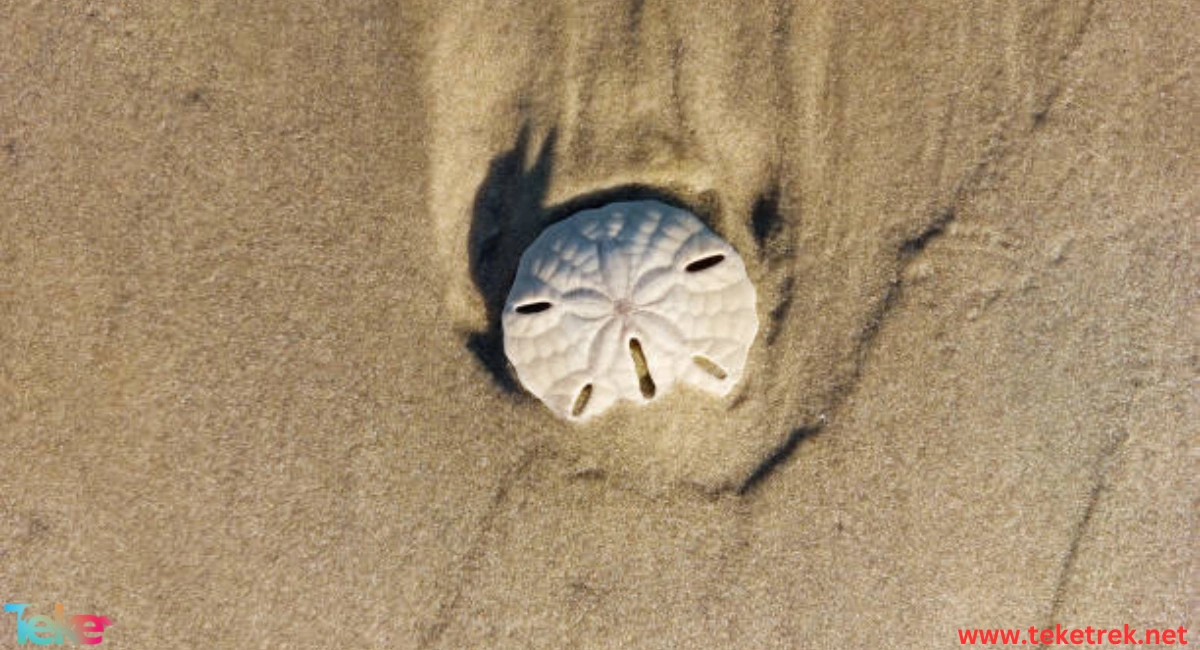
467 125 720 393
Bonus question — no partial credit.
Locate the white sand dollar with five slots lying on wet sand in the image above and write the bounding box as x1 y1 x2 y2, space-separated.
502 200 758 421
